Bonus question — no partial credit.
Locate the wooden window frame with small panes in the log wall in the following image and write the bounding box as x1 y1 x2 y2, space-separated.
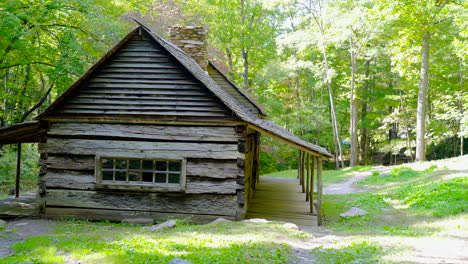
95 155 187 192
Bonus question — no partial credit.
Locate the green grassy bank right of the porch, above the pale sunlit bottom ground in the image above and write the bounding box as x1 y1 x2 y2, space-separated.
323 161 468 236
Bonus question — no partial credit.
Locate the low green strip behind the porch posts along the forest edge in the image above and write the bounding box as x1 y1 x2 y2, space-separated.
262 166 372 185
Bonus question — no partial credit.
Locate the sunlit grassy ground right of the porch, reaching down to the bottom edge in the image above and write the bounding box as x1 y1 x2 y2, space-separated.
312 158 468 263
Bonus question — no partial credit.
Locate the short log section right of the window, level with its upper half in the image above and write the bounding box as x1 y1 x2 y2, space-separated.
187 159 239 179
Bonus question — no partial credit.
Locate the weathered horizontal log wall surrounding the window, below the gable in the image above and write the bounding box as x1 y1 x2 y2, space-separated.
39 123 252 222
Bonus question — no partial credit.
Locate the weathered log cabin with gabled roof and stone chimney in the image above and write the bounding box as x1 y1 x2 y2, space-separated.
0 24 332 222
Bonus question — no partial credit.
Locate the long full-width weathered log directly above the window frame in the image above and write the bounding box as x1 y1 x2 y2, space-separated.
39 138 243 159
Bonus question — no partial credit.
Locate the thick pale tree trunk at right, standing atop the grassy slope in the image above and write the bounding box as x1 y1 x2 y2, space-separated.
416 32 430 161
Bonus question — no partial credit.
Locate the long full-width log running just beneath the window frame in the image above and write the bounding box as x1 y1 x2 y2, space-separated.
44 189 237 216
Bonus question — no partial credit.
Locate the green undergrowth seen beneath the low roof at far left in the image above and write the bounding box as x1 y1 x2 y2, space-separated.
0 144 39 199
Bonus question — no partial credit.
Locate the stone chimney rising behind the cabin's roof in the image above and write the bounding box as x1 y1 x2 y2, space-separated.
170 26 208 71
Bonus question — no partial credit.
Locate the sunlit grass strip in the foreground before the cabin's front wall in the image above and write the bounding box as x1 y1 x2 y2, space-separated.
0 221 308 263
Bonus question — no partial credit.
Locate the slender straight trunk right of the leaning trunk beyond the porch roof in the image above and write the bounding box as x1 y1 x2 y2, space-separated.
349 37 358 167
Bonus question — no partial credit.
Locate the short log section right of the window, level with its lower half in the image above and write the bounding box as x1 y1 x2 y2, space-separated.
185 177 240 195
